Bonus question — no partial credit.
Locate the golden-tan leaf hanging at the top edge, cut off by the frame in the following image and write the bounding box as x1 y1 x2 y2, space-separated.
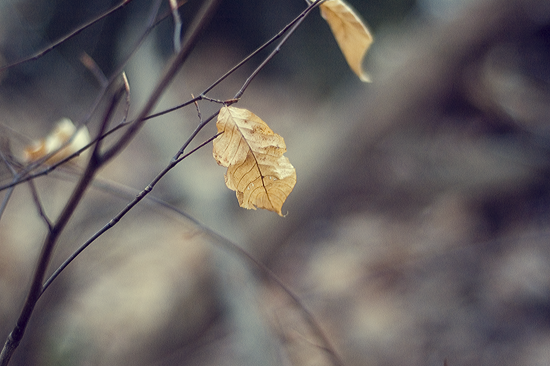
320 0 372 82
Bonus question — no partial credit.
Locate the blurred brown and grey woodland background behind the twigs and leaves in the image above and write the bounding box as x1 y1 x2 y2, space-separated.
0 0 550 366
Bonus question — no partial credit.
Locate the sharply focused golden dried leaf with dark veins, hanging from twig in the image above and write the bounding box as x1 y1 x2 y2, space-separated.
213 107 296 216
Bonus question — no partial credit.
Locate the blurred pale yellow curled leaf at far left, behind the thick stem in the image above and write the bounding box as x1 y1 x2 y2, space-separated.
23 118 90 165
